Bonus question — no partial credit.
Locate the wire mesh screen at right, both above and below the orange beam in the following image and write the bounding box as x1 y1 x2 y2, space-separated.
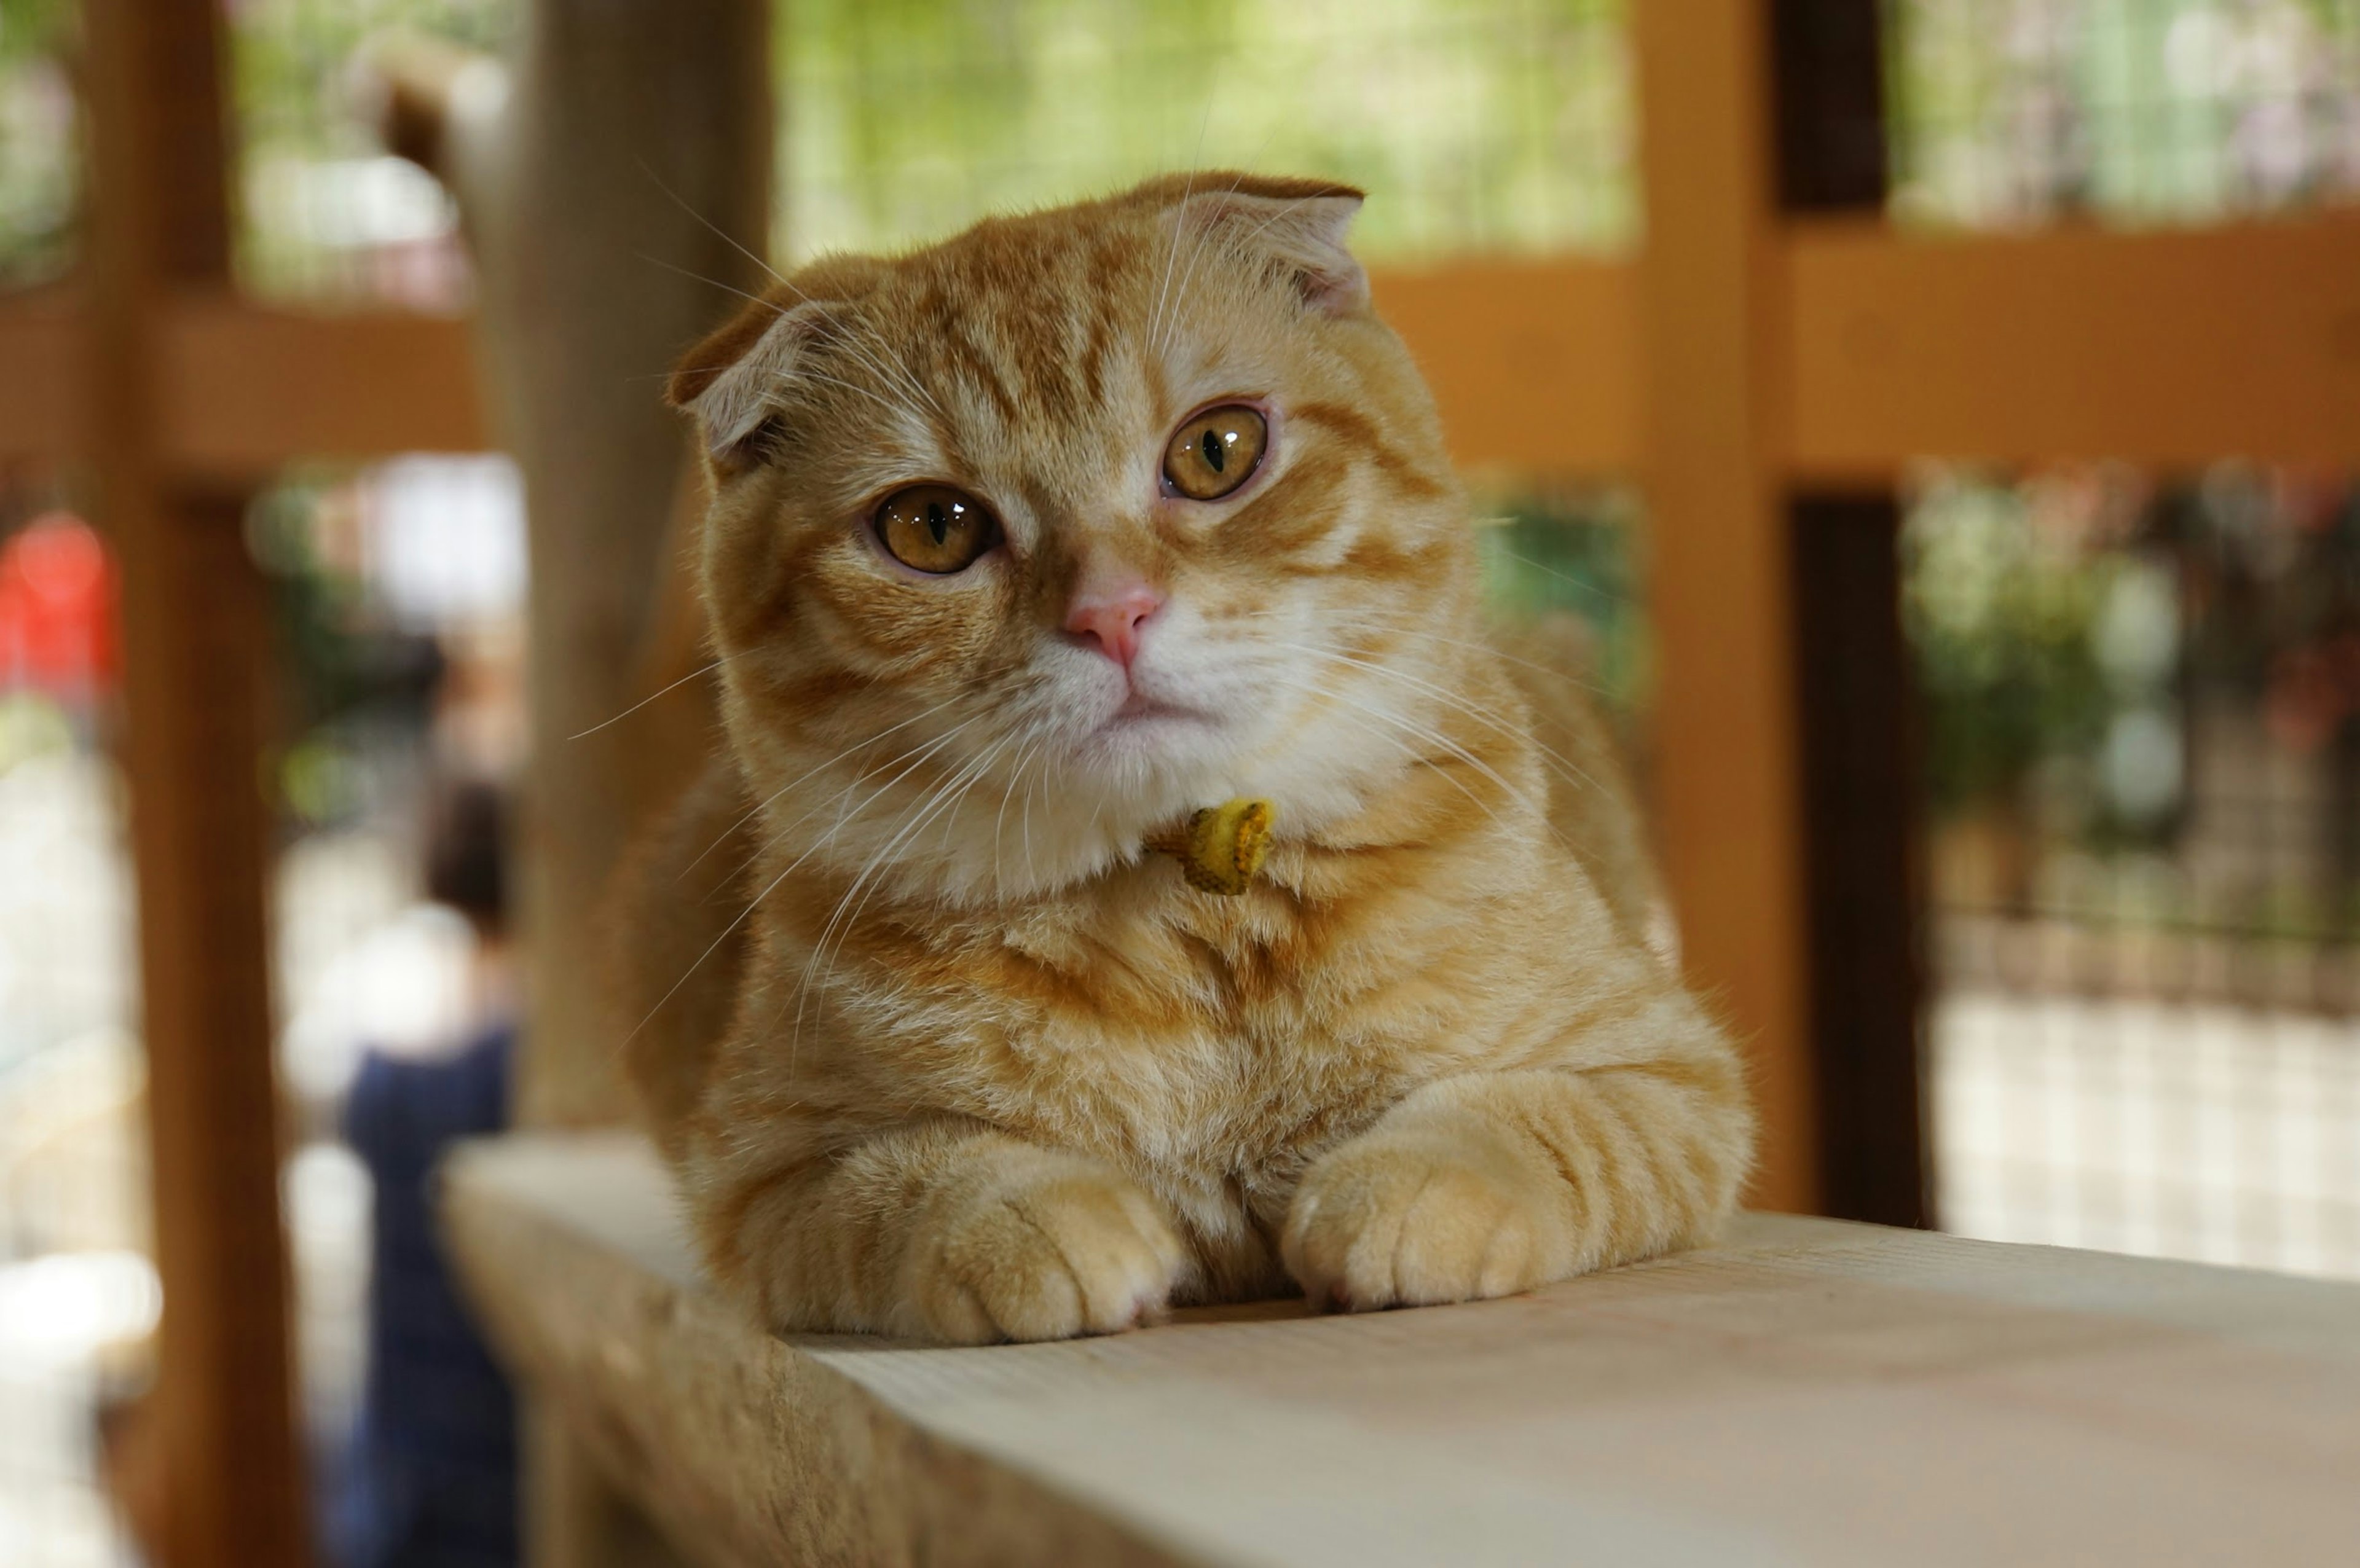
1886 0 2360 1273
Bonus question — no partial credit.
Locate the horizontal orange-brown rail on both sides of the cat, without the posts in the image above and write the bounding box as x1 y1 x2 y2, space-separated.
18 212 2360 486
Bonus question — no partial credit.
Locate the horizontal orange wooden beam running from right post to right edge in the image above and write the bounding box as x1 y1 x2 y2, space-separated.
1777 212 2360 481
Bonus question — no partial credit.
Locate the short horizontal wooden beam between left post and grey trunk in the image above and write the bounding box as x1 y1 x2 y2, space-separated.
155 295 491 479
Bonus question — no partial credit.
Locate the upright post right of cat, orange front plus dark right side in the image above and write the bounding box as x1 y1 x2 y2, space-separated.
1633 0 1924 1224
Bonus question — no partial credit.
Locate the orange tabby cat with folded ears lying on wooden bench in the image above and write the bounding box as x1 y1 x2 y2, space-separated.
618 174 1753 1342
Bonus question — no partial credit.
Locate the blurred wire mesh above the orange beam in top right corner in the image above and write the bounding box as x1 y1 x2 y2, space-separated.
1886 0 2360 226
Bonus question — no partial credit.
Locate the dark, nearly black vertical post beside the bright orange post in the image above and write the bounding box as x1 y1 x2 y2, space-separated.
1772 0 1928 1226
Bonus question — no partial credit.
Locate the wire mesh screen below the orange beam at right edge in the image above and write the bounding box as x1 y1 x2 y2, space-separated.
1905 467 2360 1273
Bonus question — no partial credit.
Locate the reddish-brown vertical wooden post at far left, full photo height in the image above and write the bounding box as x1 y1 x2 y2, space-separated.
82 0 307 1568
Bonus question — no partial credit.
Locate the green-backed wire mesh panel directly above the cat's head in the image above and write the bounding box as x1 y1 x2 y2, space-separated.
781 0 1638 259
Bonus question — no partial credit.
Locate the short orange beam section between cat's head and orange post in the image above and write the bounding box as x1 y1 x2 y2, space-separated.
1371 257 1640 476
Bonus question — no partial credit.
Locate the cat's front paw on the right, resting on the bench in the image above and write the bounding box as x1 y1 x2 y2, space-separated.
1279 1134 1571 1311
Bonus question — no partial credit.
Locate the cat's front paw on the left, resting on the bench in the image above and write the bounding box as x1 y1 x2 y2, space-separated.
904 1169 1189 1344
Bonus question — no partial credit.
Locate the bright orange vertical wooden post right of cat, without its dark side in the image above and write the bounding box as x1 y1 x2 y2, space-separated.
1630 0 1820 1212
